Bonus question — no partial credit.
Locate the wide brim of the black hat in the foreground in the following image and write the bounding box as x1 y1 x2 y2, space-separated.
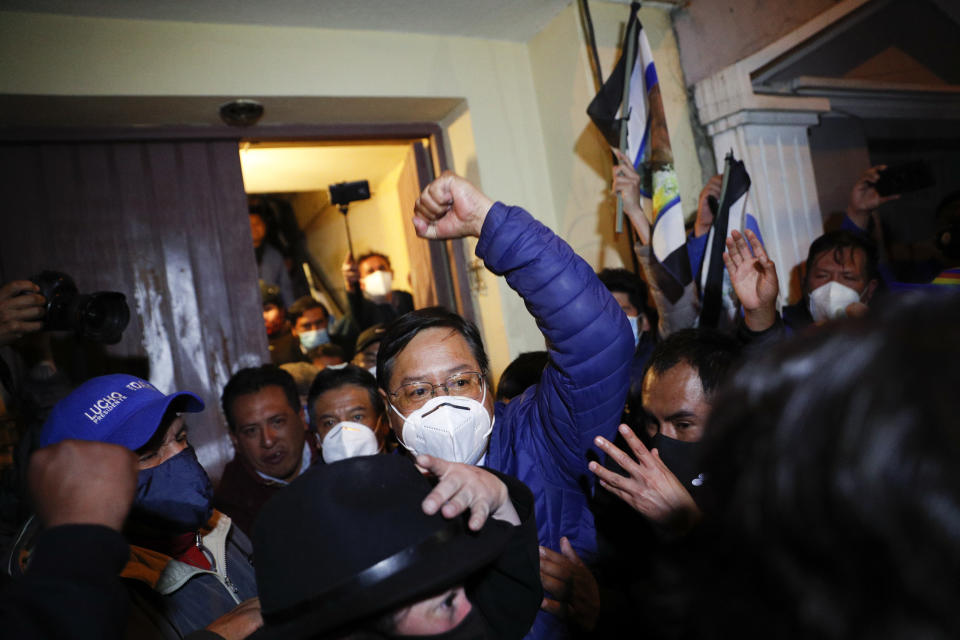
250 519 514 640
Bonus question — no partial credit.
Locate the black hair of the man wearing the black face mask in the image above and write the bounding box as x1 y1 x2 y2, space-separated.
643 328 740 399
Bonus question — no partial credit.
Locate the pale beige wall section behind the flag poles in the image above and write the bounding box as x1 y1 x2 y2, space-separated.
530 2 702 269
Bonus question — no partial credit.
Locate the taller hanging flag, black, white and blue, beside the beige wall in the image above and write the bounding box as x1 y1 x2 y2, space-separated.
587 2 693 301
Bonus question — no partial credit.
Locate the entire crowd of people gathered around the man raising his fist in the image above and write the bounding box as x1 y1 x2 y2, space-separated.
0 158 960 640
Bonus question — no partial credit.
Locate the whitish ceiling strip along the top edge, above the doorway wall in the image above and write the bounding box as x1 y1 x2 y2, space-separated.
0 0 588 42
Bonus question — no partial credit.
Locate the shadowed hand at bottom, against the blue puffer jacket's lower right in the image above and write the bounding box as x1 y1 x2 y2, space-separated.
540 538 600 631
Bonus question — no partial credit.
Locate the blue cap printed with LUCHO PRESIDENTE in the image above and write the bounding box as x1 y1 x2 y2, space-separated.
40 373 203 451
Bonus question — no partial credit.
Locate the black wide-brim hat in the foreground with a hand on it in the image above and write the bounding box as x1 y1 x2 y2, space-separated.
251 455 513 640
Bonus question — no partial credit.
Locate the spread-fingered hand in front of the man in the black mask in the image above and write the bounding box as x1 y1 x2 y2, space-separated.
589 424 700 533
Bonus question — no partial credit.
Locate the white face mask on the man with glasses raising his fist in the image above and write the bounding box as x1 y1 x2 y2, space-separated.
390 385 493 464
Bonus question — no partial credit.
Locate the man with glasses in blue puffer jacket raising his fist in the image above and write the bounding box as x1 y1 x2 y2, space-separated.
377 173 633 638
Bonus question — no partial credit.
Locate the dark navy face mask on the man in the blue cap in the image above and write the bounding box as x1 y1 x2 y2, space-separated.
131 447 213 534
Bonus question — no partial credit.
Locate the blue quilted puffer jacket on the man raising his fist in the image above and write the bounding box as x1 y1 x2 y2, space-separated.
476 202 634 638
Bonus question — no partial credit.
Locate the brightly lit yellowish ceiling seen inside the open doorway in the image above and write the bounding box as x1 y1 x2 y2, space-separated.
240 143 410 193
